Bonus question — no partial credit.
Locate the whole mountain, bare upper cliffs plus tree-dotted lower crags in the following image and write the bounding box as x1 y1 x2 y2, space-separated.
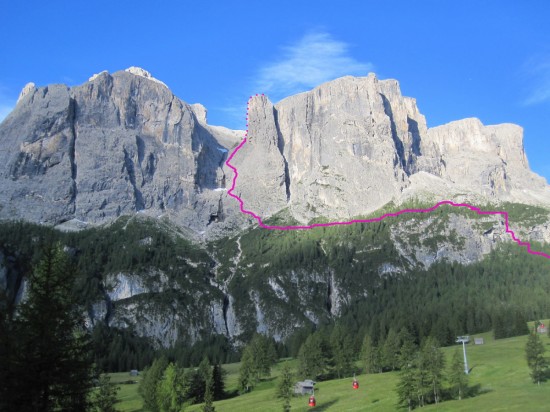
0 67 550 346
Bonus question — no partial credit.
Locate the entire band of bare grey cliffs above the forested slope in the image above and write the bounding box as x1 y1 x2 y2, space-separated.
0 67 550 236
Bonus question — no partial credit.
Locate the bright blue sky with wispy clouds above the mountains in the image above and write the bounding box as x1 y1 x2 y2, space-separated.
0 0 550 181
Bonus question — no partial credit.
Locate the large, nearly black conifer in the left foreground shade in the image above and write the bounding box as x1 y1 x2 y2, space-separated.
2 245 92 411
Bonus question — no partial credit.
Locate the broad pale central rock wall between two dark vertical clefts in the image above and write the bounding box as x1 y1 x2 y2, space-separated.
275 75 410 221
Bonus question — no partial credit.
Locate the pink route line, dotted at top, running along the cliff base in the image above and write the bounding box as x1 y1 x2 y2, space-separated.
225 94 550 259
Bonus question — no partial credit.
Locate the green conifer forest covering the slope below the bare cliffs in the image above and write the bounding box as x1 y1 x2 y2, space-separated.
0 202 550 408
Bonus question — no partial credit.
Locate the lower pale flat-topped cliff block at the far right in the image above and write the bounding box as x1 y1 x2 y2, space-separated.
420 119 550 205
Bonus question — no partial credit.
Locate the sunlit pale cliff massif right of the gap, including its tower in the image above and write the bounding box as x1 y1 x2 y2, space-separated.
240 74 550 223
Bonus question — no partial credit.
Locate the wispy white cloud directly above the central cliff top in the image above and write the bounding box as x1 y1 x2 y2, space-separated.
255 32 374 101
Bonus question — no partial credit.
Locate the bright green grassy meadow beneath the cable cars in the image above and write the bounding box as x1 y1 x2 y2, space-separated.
111 321 550 412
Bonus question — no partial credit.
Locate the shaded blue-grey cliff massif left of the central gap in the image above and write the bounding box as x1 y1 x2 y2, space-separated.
0 69 244 235
